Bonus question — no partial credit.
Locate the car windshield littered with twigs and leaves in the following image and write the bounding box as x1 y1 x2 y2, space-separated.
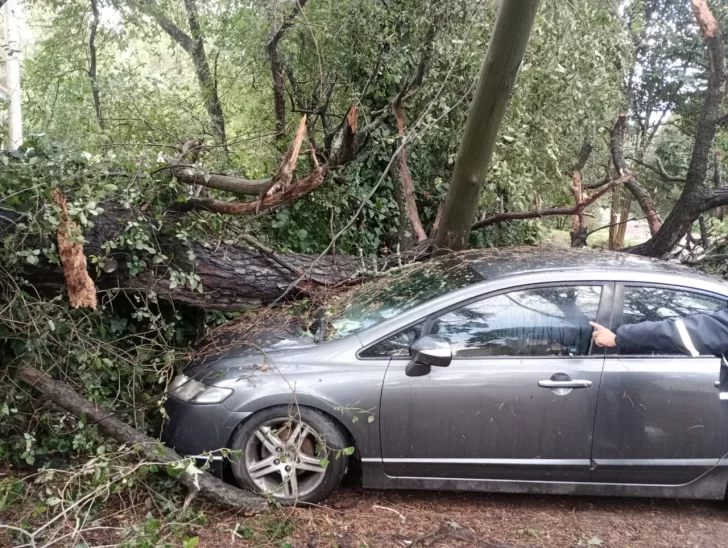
327 255 484 339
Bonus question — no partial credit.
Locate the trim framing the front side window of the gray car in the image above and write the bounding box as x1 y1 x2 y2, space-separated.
420 280 615 361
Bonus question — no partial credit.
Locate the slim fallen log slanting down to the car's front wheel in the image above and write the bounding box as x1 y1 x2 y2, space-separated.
16 366 268 512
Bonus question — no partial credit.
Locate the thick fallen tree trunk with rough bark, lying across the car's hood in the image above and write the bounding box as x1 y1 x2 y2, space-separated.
6 209 361 311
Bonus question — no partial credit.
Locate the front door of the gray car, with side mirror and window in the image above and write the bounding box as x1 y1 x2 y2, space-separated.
380 283 612 481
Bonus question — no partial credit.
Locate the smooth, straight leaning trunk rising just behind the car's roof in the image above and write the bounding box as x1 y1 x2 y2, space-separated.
435 0 539 253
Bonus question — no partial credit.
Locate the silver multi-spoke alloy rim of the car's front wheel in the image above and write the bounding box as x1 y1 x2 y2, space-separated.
244 418 326 499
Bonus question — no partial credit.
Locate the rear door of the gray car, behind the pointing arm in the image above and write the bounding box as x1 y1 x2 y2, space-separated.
592 284 728 485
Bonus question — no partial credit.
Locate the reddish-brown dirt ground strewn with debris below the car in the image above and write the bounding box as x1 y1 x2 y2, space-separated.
196 488 728 548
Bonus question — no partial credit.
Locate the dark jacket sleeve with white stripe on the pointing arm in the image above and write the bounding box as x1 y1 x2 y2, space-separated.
616 309 728 356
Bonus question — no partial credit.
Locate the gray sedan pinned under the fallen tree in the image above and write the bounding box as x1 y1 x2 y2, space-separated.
164 248 728 503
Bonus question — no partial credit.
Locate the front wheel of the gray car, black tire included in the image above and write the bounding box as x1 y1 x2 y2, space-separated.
230 405 349 505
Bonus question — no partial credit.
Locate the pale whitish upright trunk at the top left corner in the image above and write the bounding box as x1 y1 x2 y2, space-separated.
5 0 23 150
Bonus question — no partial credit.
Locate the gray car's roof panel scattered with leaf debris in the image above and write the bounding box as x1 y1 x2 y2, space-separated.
462 246 715 280
